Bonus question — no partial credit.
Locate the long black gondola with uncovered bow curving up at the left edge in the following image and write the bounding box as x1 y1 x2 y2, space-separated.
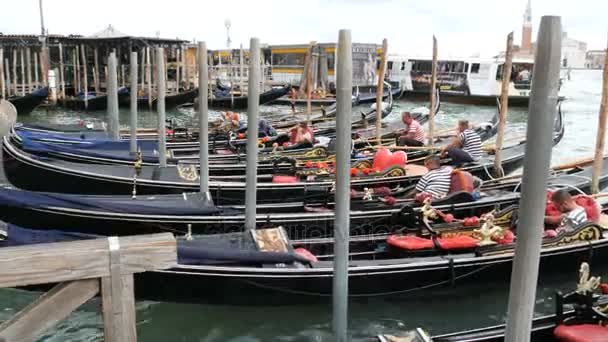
3 103 564 204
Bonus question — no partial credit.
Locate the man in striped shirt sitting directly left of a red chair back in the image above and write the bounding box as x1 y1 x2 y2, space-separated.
416 155 453 200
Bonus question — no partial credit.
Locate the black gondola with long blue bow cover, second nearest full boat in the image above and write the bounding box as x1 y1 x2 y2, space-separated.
0 151 608 239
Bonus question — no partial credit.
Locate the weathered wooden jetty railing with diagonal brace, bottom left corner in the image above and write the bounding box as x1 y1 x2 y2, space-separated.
0 233 177 342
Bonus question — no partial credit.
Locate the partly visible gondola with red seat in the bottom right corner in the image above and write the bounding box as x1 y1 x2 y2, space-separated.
370 263 608 342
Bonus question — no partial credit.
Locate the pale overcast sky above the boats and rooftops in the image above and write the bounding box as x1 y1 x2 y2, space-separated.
0 0 608 56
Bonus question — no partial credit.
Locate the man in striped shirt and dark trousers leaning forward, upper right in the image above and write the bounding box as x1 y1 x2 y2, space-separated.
441 120 481 165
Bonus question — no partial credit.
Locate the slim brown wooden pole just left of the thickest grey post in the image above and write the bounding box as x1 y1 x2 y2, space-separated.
494 32 513 177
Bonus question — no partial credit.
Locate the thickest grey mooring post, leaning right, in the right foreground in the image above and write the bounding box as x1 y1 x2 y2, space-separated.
505 16 562 342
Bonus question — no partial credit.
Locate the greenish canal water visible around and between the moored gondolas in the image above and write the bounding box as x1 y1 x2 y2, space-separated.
0 70 608 342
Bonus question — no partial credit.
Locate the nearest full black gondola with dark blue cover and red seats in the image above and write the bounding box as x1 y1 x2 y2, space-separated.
1 200 608 305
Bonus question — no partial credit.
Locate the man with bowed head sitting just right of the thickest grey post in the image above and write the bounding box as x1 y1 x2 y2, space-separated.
545 189 587 233
